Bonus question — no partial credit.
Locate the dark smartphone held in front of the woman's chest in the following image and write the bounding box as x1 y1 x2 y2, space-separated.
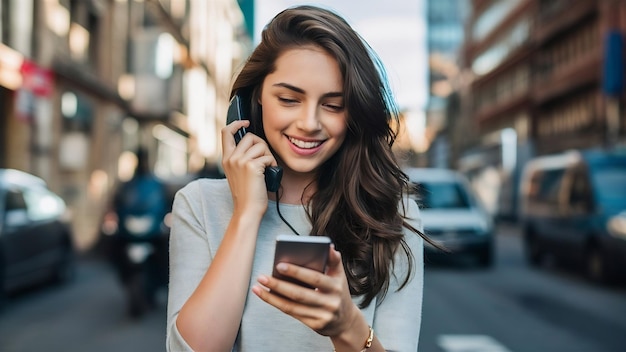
272 235 331 288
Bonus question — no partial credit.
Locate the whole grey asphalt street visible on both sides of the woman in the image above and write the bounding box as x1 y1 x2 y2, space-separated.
0 226 626 352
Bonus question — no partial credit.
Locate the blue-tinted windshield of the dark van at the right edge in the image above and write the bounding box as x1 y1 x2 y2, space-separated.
591 165 626 208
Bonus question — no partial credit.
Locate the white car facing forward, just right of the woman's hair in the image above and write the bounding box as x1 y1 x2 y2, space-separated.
404 168 494 267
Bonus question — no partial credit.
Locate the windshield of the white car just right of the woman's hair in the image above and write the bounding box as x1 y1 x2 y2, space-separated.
415 182 470 209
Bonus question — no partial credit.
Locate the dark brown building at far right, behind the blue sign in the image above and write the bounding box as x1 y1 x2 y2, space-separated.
530 0 626 154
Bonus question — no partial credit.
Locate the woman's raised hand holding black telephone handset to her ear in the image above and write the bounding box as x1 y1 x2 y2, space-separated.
222 120 277 215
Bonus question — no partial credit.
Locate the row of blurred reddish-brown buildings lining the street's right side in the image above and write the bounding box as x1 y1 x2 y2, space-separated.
448 0 626 217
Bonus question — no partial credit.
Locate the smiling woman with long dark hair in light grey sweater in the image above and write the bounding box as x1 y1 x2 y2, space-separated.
167 6 423 352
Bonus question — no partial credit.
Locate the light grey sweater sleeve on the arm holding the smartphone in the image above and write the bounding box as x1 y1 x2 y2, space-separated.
372 199 424 352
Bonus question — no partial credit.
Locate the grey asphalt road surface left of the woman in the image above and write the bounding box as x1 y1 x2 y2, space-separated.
0 253 166 352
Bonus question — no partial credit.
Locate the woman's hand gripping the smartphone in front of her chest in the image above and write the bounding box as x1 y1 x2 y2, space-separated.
252 246 360 337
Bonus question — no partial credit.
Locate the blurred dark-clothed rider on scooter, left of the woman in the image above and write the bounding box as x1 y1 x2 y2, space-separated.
108 148 171 316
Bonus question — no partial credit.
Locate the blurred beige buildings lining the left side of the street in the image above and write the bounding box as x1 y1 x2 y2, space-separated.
0 0 251 252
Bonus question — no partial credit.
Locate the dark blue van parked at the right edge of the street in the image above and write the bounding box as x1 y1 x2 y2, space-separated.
520 150 626 283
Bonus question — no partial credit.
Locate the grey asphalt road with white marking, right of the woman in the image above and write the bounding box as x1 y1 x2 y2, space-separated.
420 226 626 352
